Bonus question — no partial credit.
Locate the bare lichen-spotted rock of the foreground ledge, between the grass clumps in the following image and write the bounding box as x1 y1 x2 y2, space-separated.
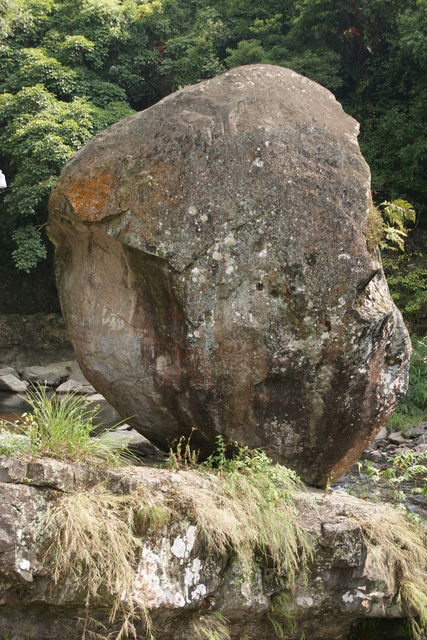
0 457 418 640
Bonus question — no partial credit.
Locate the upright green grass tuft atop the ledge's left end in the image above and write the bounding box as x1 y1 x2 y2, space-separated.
4 386 133 466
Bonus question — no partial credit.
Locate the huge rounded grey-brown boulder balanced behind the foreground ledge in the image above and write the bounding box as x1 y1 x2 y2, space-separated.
49 65 410 485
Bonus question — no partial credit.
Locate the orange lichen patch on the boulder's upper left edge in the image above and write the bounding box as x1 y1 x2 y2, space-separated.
56 171 117 222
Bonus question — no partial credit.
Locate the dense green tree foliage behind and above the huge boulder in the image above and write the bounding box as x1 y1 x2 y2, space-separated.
0 0 427 308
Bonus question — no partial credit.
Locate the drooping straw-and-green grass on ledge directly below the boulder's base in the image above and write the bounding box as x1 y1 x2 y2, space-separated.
180 467 312 586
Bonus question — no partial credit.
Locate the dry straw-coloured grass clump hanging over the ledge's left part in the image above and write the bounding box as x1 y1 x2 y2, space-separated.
40 486 171 640
